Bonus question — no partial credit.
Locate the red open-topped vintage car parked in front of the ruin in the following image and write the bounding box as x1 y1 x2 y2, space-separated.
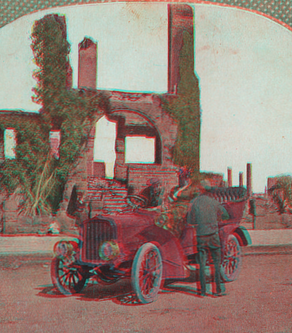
51 187 251 303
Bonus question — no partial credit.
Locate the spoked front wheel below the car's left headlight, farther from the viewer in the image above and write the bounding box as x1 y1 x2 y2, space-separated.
51 258 88 295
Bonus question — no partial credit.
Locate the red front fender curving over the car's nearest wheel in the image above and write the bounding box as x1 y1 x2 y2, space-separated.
140 226 187 279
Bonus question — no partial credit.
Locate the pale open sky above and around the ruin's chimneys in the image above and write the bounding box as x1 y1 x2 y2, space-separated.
0 3 292 192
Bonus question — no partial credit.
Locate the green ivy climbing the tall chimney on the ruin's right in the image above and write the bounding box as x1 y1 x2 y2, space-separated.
162 31 200 177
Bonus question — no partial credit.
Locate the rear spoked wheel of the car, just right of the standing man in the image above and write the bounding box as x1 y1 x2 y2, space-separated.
221 234 242 282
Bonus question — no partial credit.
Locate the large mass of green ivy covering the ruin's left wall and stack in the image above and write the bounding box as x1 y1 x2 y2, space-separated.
0 15 109 215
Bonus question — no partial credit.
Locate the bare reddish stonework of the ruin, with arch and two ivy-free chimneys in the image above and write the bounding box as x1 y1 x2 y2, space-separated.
60 4 194 217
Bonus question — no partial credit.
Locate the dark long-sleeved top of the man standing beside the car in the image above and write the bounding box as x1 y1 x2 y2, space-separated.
187 195 229 236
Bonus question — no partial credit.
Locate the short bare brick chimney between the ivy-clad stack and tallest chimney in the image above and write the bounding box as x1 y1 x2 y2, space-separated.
78 37 97 89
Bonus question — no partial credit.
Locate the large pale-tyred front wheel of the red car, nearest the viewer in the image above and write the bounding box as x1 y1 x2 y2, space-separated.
131 243 162 304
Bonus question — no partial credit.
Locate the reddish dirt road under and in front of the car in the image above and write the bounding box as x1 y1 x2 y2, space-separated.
0 255 292 333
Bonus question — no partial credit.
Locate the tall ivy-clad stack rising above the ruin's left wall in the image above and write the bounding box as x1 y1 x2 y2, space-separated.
31 15 70 126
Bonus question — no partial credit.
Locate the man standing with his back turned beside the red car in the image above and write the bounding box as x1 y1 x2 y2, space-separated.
187 185 229 296
